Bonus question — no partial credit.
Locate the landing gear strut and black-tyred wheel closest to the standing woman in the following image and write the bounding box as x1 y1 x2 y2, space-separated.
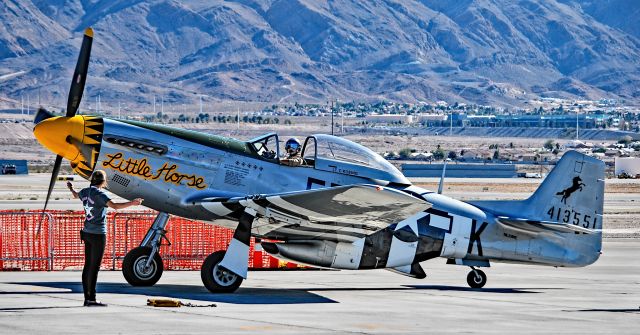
122 212 171 286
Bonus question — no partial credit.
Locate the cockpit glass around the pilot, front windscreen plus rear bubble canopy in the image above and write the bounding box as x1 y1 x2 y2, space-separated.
249 133 411 185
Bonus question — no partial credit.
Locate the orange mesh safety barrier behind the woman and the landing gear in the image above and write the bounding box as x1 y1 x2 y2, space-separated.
0 211 298 271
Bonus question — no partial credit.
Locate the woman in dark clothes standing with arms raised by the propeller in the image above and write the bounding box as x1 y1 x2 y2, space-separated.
67 170 143 306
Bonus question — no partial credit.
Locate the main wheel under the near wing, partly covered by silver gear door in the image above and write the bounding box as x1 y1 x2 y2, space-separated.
200 250 243 293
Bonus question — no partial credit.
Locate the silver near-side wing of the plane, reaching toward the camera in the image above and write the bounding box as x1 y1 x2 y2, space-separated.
202 184 431 242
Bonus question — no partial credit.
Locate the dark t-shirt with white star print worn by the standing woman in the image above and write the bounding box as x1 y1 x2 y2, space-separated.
78 186 111 234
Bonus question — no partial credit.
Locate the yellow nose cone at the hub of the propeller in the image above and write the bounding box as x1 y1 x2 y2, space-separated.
33 115 84 161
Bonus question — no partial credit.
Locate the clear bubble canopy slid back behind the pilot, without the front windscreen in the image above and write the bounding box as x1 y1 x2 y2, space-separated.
304 134 411 184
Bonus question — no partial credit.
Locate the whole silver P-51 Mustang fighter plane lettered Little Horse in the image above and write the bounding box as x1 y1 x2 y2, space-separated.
34 29 604 292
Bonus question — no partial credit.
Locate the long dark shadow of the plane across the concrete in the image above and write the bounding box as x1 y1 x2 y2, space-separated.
0 282 548 305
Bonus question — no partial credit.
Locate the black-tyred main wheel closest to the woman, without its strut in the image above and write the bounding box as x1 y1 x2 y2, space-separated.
122 247 164 286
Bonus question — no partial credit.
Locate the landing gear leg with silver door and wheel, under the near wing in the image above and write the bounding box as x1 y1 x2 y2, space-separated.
200 208 256 293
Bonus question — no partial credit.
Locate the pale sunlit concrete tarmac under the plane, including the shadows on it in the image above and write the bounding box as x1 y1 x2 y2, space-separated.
0 239 640 334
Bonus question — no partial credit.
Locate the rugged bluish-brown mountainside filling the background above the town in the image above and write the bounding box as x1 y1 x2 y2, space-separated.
0 0 640 108
